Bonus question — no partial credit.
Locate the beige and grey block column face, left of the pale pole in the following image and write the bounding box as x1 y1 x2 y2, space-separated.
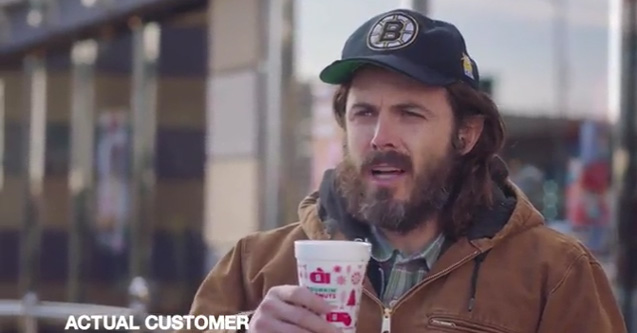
204 0 268 256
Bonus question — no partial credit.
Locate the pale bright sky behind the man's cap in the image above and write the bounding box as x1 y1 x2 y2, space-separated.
294 0 609 117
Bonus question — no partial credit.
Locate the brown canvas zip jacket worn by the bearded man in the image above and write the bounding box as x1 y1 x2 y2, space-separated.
181 182 626 333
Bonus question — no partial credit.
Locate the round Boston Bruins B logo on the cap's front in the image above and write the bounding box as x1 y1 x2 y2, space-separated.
367 13 418 50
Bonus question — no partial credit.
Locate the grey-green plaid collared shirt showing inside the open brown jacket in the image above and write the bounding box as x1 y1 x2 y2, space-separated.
370 228 445 307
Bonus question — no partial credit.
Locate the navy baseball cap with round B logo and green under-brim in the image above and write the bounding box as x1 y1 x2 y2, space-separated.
319 9 480 89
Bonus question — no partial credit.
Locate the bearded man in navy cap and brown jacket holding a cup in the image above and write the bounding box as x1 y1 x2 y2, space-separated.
185 10 626 333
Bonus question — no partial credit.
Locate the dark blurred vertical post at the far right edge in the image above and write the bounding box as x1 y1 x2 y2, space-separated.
613 0 637 332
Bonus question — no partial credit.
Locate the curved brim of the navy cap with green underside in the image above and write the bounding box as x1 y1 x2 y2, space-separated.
319 54 458 86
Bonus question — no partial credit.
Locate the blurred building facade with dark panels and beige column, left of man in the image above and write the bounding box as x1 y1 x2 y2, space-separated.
0 0 310 322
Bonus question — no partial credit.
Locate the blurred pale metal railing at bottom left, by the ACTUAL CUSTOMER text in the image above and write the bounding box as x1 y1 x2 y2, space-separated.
0 277 159 333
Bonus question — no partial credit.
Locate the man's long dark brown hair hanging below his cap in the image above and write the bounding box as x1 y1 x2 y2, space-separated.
332 82 507 239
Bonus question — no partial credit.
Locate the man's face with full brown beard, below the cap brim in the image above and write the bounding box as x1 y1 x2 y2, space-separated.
337 68 454 233
